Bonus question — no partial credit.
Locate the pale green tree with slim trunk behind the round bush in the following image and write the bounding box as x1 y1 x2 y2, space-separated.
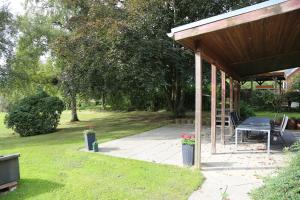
6 1 78 121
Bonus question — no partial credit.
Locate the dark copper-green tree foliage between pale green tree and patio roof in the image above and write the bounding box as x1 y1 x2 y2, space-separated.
33 0 262 116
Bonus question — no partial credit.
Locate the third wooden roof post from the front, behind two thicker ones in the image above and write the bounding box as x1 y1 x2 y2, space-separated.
221 71 226 144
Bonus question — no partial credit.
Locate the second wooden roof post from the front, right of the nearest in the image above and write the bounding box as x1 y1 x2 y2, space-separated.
211 65 217 153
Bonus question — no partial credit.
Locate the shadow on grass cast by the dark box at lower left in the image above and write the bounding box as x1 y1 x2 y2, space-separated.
0 179 64 200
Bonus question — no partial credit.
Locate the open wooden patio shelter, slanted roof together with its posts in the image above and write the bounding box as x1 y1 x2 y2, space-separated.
168 0 300 168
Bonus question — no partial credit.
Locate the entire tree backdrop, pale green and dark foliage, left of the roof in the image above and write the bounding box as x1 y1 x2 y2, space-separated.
5 0 260 118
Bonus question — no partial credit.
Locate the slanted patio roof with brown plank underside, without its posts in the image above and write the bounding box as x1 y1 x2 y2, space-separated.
169 0 300 79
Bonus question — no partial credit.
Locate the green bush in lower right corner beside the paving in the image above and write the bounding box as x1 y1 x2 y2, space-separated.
251 144 300 200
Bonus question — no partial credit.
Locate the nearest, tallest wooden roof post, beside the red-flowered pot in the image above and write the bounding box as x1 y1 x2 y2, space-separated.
195 51 202 169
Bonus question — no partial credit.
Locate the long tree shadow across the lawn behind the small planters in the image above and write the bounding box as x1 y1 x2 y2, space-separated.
0 111 168 151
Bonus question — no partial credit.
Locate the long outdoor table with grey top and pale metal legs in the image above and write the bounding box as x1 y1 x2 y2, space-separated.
235 117 271 154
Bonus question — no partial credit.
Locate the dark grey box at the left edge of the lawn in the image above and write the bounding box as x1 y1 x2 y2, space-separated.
0 154 20 187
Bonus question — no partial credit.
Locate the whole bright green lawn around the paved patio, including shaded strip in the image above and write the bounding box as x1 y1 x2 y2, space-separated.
0 111 203 200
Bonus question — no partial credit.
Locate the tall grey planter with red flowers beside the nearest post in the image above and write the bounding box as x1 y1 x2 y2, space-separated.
181 133 195 166
